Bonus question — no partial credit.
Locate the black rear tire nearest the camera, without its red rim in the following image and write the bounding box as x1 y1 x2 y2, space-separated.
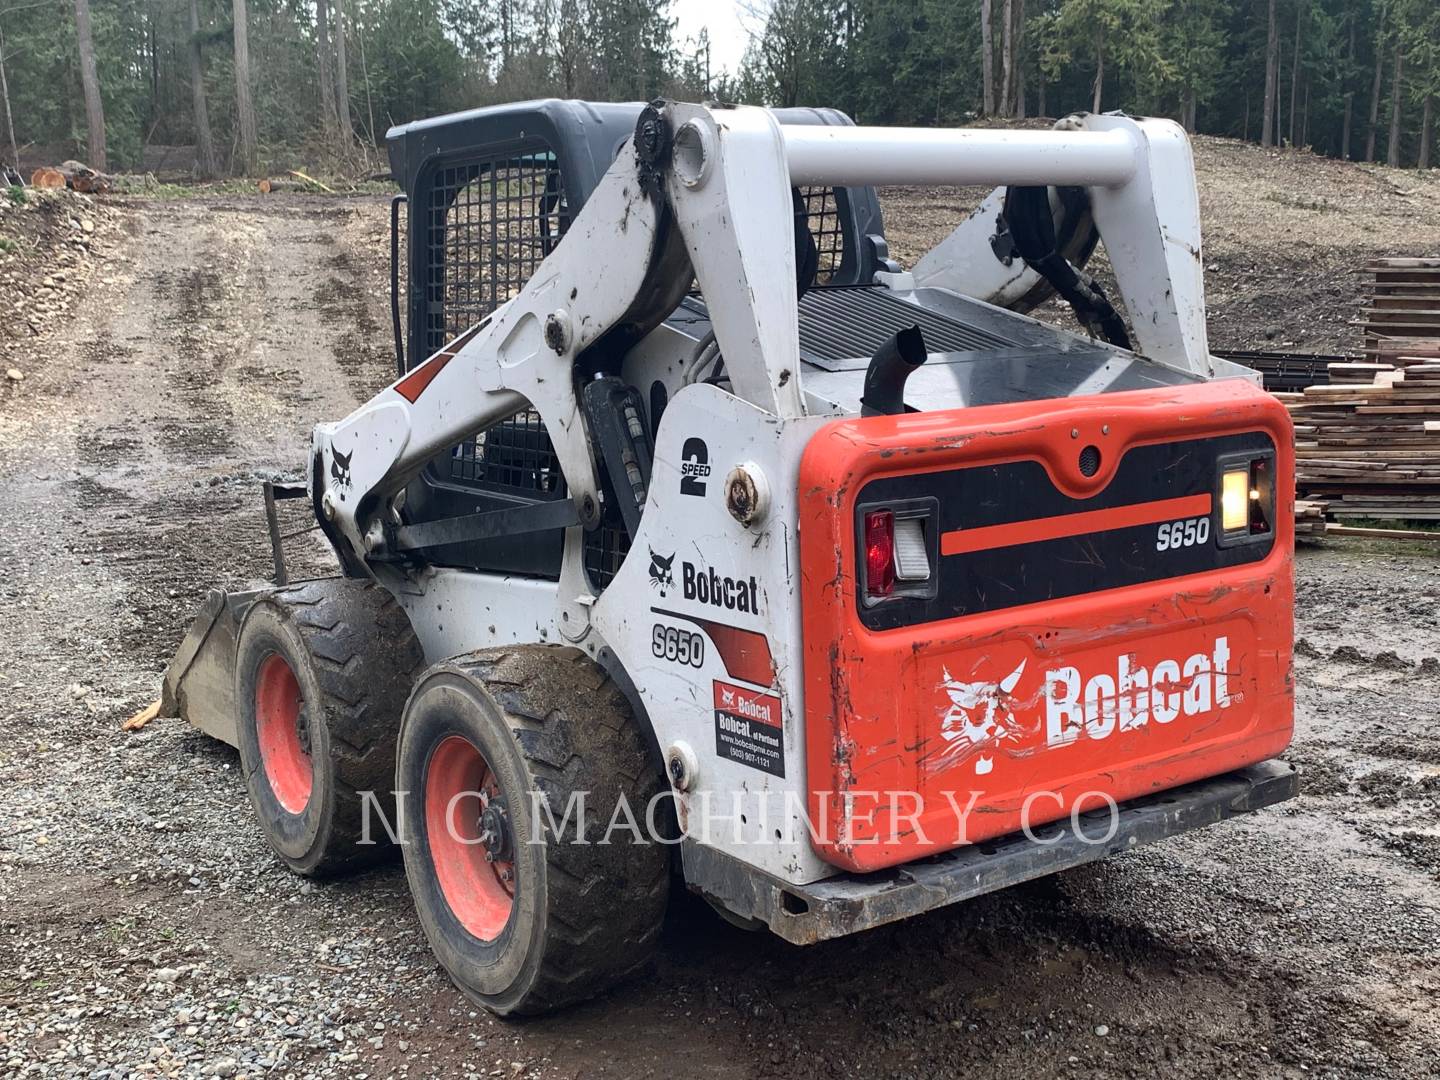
396 645 671 1015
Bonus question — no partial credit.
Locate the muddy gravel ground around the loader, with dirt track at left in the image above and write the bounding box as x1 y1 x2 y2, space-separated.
0 141 1440 1079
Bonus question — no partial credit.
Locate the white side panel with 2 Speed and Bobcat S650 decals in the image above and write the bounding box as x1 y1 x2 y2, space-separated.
592 386 835 883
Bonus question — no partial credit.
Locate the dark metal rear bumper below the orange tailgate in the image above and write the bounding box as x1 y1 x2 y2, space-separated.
683 760 1300 945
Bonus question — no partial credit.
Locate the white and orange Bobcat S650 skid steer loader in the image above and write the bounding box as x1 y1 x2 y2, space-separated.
166 101 1297 1014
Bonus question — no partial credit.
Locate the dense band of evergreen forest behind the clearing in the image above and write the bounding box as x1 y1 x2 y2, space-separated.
0 0 1440 173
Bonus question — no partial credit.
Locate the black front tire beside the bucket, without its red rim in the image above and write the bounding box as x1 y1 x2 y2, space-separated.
235 577 425 877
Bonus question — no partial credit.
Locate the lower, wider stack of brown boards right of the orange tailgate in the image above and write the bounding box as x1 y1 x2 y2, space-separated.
1277 364 1440 521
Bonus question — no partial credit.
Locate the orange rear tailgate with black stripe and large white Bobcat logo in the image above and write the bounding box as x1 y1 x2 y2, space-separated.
799 379 1295 873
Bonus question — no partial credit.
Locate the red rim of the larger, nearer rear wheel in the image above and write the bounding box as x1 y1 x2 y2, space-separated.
425 734 516 942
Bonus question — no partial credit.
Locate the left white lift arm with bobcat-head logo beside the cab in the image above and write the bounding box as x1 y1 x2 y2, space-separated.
310 109 691 569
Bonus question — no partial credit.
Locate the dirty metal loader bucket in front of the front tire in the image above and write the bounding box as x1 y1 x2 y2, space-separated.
160 589 261 746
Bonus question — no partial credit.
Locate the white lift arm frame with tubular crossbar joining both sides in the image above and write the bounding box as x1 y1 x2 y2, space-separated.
311 104 1212 584
